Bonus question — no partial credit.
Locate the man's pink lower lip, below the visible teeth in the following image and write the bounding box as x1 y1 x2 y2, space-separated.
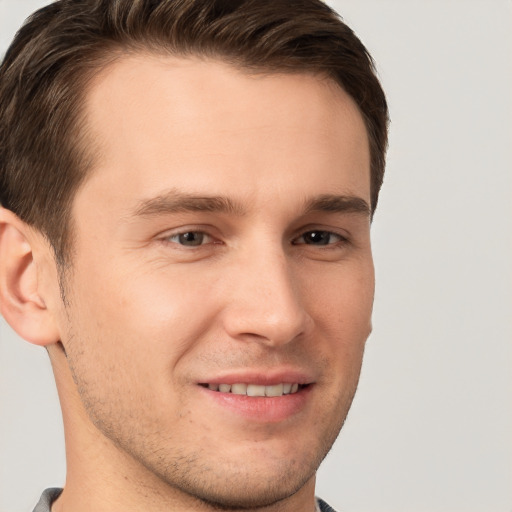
200 384 313 423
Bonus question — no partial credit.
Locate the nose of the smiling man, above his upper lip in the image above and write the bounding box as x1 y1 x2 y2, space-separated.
223 245 313 347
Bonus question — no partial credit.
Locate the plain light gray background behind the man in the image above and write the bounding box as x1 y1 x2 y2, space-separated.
0 0 512 512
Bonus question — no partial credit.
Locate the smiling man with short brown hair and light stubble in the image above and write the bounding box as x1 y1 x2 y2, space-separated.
0 0 387 512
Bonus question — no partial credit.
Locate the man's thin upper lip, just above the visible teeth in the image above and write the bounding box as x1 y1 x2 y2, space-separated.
198 368 314 386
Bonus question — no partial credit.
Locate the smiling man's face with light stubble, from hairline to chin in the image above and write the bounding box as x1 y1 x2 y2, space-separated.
56 56 374 507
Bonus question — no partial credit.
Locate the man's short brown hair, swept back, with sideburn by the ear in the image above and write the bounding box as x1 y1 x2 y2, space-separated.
0 0 388 264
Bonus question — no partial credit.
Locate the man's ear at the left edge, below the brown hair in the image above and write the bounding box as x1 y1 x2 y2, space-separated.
0 207 60 346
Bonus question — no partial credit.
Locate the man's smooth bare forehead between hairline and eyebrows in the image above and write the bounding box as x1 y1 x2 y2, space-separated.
76 54 370 216
